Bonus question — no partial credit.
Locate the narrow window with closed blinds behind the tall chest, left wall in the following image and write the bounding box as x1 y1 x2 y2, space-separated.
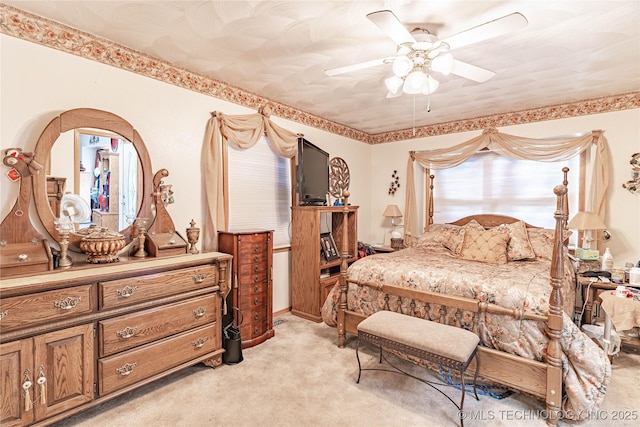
229 137 291 245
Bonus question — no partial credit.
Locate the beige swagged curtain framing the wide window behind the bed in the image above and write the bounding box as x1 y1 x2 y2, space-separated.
405 129 609 241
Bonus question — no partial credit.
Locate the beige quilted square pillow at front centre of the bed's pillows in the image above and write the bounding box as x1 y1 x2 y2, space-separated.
460 228 509 264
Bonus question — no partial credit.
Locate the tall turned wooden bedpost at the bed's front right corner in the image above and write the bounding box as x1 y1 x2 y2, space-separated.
546 182 567 426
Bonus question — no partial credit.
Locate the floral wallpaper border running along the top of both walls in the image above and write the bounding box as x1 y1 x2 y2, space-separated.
0 3 640 144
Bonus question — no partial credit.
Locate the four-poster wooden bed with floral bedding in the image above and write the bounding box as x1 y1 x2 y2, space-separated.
322 172 611 425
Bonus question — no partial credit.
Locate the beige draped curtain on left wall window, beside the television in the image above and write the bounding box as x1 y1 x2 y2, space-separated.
202 106 298 251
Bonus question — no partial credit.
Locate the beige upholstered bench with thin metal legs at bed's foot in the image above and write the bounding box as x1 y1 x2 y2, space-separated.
356 311 480 426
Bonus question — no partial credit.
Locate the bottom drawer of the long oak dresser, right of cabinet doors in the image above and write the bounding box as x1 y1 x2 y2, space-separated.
98 323 221 396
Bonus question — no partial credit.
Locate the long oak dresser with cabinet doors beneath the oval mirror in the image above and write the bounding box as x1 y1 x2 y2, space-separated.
0 252 231 427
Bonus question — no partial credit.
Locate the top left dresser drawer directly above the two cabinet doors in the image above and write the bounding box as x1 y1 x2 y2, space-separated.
0 285 95 332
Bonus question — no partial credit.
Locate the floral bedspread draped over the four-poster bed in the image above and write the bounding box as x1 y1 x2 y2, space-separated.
322 247 611 420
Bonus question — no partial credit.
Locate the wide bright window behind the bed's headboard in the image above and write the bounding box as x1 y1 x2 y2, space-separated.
432 151 580 228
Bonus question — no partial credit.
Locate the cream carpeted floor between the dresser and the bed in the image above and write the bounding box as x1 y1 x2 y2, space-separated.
55 314 640 427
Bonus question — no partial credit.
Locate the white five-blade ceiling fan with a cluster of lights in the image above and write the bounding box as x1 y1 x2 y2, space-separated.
325 10 527 98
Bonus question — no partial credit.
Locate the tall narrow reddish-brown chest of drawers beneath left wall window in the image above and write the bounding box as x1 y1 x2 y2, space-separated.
218 231 274 348
